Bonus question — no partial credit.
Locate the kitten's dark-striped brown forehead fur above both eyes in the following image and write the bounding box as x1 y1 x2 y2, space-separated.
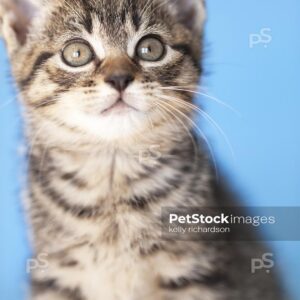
43 0 168 47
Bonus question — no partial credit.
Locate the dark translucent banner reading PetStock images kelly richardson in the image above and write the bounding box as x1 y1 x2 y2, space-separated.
161 207 300 241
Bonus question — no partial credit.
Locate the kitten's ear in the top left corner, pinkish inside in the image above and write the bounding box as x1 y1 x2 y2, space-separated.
0 0 37 53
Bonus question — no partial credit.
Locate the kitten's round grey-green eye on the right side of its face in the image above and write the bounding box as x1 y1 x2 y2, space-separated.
136 37 165 61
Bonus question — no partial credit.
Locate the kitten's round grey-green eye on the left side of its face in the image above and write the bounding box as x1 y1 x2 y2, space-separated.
62 41 94 68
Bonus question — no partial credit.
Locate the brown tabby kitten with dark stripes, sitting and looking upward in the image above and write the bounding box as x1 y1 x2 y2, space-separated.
0 0 282 300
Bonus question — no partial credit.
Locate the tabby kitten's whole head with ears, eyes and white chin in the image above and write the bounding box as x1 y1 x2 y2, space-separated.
0 0 204 145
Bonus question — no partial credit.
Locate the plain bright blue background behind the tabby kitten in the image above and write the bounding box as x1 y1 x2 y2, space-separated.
0 0 300 300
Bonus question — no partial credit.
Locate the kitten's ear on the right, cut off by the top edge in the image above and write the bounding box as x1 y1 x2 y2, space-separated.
170 0 205 34
